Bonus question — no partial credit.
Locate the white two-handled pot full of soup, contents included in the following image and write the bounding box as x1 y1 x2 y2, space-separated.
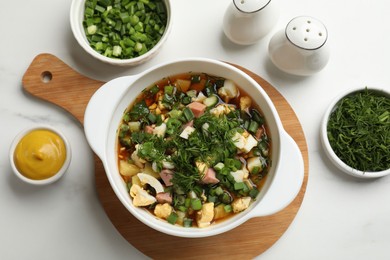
84 58 304 238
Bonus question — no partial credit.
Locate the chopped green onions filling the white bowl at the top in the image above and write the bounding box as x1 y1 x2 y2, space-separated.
83 0 168 59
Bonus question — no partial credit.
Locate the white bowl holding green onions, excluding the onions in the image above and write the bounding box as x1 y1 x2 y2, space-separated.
70 0 172 66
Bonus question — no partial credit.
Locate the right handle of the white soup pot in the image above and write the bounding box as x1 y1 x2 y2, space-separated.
249 132 304 218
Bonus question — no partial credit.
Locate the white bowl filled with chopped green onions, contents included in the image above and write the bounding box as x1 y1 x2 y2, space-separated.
70 0 171 66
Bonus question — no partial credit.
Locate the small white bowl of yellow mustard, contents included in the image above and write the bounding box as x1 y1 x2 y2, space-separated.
10 126 71 185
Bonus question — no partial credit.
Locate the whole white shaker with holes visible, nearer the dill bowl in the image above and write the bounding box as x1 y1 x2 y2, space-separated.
268 16 330 76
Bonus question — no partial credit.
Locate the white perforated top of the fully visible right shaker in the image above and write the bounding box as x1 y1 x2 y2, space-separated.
286 16 328 50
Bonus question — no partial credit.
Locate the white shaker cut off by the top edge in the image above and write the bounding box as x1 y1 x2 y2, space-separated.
223 0 279 45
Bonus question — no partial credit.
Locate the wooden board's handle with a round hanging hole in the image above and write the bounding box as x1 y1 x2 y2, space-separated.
22 53 105 124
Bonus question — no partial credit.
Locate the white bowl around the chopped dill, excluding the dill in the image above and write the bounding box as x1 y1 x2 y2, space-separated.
320 87 390 178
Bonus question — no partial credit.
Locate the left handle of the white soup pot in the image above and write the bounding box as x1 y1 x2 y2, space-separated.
84 76 136 159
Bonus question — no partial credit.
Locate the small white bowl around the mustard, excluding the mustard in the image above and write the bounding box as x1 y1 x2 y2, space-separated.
9 125 72 185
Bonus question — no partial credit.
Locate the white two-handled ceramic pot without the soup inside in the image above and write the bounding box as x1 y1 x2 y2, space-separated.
84 58 304 237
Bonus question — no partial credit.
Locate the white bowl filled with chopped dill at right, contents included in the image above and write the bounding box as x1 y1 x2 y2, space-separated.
321 87 390 178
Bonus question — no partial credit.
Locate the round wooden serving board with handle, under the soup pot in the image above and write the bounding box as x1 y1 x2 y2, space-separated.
23 54 309 259
